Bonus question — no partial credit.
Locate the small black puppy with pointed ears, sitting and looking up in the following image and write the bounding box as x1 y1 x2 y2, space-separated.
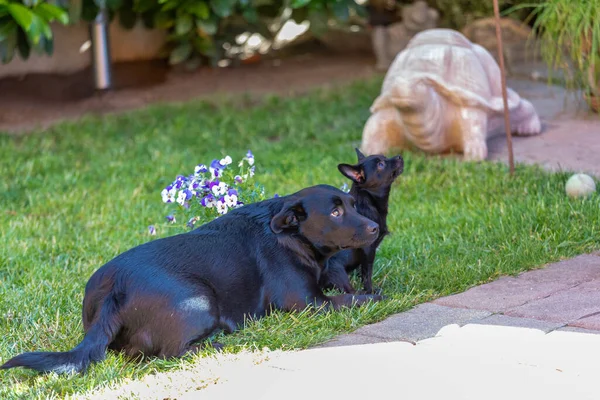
320 149 404 293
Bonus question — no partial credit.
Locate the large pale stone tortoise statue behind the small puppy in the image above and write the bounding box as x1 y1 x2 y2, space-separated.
361 29 541 161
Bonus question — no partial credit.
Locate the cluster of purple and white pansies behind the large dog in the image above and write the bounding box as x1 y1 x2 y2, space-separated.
161 150 264 228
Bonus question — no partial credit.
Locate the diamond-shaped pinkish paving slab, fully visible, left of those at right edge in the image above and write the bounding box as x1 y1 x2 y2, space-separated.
434 277 571 313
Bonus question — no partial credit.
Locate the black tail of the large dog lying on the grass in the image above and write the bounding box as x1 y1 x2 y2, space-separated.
0 293 121 374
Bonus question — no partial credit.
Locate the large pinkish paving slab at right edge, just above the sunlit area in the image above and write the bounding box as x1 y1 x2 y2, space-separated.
505 280 600 324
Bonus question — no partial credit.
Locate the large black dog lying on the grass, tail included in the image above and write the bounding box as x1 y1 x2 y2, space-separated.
0 185 381 373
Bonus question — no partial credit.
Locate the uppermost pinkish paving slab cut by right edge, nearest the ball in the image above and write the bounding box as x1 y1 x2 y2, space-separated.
518 254 600 286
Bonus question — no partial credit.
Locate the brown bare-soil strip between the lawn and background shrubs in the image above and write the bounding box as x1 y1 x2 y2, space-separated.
0 52 376 133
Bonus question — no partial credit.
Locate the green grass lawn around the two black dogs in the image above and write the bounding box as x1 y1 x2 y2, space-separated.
0 77 600 399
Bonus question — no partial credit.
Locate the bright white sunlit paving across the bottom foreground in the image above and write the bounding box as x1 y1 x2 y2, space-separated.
86 324 600 400
